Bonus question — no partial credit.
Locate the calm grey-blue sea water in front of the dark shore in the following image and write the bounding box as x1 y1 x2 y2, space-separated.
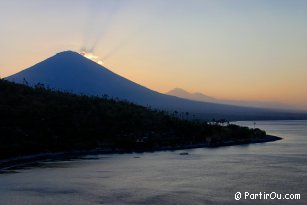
0 121 307 205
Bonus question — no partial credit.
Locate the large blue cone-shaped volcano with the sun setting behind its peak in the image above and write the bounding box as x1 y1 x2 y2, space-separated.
5 51 307 120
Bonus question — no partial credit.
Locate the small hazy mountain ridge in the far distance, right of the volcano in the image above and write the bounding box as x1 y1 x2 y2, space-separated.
166 88 293 110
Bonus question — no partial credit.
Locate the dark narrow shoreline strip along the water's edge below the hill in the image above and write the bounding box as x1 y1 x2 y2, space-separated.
0 135 283 171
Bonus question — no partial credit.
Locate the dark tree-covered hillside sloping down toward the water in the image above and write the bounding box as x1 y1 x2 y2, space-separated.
0 79 276 159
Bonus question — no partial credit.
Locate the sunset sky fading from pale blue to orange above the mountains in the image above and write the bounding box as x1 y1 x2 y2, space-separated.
0 0 307 109
